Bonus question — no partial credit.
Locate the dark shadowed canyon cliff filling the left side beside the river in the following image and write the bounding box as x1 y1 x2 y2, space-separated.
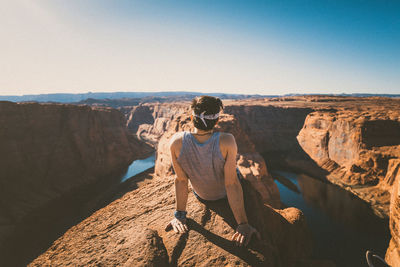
0 102 152 264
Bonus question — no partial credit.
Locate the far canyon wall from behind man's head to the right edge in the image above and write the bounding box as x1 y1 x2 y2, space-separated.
128 97 400 217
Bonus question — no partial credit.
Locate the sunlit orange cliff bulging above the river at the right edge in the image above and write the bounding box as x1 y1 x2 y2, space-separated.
297 111 400 217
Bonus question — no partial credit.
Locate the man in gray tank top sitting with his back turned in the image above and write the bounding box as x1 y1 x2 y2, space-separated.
167 96 260 246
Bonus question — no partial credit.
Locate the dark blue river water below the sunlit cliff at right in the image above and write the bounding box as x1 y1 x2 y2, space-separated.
275 171 390 267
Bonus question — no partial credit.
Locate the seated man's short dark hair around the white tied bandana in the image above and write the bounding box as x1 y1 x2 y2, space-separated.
190 95 224 131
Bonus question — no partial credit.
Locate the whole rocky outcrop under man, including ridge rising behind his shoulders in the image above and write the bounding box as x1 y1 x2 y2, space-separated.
30 109 330 266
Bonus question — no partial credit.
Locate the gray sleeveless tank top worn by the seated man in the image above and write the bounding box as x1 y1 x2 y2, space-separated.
177 131 226 200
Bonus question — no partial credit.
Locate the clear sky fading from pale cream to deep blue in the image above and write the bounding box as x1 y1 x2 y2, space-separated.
0 0 400 95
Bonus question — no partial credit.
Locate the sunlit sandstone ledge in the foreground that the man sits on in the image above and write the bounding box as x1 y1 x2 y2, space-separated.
30 169 310 266
